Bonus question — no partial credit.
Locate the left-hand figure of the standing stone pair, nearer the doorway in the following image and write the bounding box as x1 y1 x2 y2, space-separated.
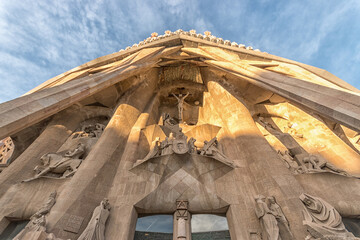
255 195 281 240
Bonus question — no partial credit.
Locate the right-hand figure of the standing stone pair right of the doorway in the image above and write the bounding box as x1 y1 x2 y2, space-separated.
267 196 294 240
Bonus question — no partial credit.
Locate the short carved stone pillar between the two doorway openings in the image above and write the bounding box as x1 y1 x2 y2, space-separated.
173 200 191 240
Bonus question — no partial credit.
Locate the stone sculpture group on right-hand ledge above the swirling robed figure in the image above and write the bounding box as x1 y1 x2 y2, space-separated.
278 150 350 176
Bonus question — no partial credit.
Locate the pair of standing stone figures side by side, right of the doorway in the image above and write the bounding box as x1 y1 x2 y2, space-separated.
255 195 293 240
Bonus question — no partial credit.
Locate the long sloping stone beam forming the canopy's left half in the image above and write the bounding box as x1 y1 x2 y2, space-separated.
0 47 180 138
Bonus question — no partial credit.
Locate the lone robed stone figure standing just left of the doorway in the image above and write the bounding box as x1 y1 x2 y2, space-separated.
78 198 111 240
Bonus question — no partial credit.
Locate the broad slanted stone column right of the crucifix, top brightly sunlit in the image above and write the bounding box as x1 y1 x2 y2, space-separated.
206 81 306 239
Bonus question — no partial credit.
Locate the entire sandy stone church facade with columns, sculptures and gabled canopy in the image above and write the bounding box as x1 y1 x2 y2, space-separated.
0 30 360 240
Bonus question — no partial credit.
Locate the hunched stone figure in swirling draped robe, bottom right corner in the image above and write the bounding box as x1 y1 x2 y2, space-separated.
300 193 356 240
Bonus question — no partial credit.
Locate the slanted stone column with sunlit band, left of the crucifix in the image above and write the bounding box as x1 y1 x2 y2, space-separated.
48 70 157 239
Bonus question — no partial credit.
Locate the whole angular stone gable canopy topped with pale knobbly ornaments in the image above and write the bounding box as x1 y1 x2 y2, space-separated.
0 30 360 138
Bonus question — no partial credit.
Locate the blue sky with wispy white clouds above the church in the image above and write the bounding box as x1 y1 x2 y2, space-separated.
0 0 360 102
